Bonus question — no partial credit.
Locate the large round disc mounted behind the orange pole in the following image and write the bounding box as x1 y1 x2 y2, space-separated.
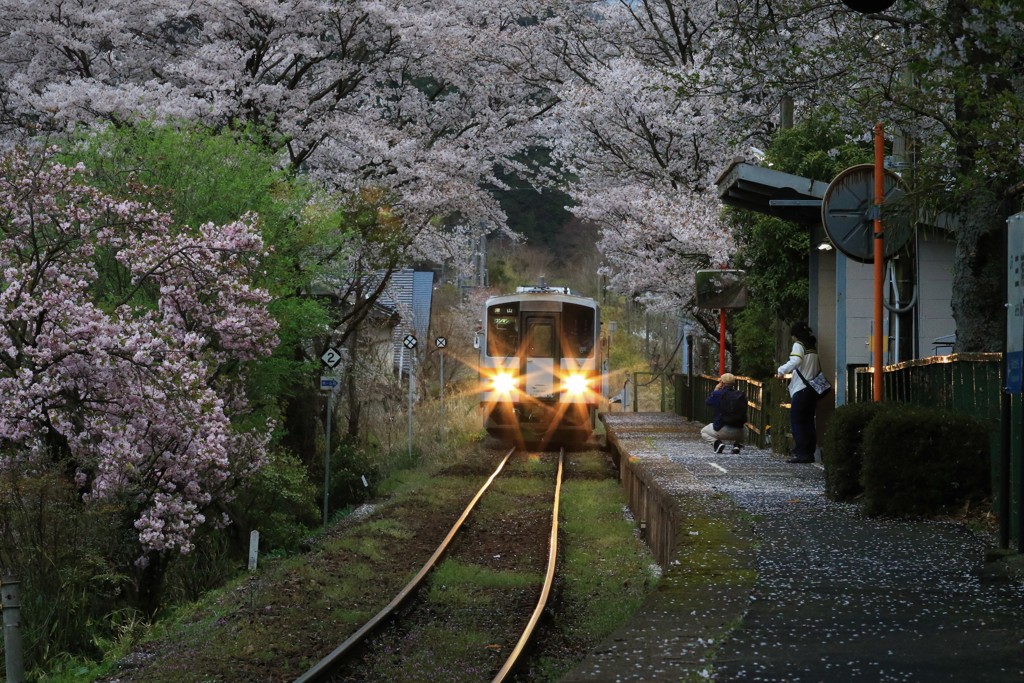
821 164 913 263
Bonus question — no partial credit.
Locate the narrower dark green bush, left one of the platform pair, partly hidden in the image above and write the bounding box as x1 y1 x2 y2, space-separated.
821 402 890 501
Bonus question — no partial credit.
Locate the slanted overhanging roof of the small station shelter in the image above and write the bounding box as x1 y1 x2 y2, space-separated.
715 159 828 224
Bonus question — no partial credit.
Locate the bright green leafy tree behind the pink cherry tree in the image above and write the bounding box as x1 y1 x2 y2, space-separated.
67 122 337 421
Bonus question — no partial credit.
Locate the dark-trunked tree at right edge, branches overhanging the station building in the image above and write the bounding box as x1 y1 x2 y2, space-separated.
719 0 1024 351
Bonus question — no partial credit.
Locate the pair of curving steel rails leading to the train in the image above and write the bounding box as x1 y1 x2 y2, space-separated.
295 449 564 683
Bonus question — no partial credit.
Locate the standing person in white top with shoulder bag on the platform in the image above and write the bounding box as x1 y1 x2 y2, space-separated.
778 323 821 463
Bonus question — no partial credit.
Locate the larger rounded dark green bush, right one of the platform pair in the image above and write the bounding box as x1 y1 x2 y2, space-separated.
861 403 991 515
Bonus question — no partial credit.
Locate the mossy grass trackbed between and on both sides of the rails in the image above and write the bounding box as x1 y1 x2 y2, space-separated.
77 452 656 683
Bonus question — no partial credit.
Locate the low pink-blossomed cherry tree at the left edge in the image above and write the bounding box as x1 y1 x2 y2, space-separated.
0 151 275 566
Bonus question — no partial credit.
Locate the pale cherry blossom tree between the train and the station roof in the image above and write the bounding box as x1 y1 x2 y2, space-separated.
549 1 753 310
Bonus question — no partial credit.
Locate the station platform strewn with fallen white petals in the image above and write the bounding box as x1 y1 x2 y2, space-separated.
560 413 1024 683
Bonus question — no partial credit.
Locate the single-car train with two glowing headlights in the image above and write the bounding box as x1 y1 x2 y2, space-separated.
474 281 606 447
